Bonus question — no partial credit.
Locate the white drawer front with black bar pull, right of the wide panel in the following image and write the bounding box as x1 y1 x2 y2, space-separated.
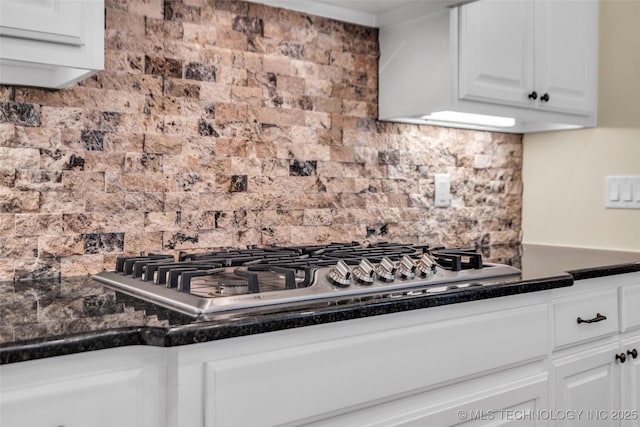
553 289 618 348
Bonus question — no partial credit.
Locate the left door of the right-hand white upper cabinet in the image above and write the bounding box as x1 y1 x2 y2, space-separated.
459 0 534 107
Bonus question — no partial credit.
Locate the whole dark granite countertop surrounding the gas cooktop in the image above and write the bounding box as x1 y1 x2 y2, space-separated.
0 245 640 364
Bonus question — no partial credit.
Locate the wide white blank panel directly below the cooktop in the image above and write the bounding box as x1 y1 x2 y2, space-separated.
204 305 548 427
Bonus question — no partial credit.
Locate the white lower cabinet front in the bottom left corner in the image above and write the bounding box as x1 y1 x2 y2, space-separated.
0 347 165 427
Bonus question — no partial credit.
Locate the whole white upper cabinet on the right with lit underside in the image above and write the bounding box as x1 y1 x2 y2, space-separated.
379 0 598 133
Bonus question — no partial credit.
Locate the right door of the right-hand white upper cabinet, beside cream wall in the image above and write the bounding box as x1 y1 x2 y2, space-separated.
535 0 598 114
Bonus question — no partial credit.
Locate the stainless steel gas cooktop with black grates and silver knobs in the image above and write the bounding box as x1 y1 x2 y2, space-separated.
93 242 520 318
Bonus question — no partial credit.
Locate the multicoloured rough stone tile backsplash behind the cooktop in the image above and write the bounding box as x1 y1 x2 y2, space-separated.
0 0 522 280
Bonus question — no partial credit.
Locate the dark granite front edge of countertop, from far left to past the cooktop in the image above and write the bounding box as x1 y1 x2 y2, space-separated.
0 274 574 365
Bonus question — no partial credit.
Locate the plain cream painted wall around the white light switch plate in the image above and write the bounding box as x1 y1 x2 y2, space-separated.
522 0 640 251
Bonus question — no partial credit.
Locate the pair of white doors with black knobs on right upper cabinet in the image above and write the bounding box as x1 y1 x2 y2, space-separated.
459 0 598 116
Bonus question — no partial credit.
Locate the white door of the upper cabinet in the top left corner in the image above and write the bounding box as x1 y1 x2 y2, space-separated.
0 0 83 45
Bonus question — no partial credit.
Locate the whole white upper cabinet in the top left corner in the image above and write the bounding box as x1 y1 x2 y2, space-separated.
0 0 104 88
